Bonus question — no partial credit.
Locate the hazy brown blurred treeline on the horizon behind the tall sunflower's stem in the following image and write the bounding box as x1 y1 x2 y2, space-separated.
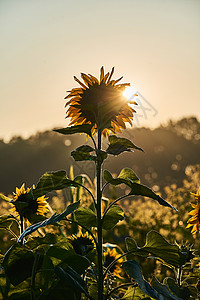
0 117 200 194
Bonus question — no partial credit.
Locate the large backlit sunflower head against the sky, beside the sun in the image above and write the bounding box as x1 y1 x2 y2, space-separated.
65 67 136 136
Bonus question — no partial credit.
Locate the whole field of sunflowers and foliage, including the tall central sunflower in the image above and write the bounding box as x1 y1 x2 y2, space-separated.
0 67 200 300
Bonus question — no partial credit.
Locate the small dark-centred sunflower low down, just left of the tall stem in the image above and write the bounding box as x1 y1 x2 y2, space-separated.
70 233 94 256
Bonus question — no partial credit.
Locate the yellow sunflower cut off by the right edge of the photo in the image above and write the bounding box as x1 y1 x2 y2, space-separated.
186 187 200 234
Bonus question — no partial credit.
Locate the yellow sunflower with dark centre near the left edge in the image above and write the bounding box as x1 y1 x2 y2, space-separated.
11 184 48 223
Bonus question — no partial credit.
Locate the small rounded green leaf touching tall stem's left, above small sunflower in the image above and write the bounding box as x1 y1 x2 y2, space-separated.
74 207 97 228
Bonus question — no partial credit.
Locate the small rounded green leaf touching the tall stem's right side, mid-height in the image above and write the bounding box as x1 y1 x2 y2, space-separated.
103 205 124 230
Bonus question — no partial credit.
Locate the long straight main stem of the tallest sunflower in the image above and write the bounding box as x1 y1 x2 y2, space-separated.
96 130 103 300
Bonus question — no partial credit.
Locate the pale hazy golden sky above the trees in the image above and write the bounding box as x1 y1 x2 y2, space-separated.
0 0 200 140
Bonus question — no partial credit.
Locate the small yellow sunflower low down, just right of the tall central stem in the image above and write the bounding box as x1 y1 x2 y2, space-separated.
104 248 123 276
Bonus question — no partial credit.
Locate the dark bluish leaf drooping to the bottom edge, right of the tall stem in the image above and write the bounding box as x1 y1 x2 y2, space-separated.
122 260 170 300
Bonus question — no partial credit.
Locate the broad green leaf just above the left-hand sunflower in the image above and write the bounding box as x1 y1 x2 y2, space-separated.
30 170 78 198
